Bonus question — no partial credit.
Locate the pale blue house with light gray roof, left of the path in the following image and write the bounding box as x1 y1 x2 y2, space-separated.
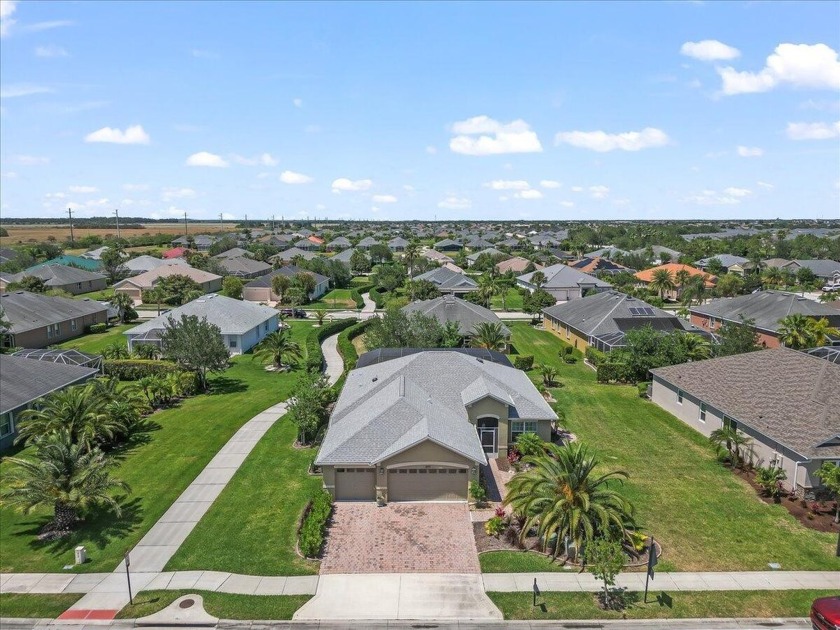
123 293 280 355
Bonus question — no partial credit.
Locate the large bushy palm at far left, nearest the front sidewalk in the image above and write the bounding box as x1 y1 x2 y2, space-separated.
0 430 131 532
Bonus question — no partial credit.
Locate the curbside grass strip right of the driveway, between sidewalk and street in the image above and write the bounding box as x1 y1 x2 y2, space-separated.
487 589 837 619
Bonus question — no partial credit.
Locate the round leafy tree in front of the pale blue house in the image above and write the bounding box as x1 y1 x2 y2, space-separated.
161 315 230 390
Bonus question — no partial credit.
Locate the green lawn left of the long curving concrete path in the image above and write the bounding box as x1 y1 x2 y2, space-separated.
0 322 311 572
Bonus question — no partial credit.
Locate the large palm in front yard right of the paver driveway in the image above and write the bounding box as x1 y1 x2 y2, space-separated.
504 442 633 557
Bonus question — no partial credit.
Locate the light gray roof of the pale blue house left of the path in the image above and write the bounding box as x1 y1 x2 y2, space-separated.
123 293 278 337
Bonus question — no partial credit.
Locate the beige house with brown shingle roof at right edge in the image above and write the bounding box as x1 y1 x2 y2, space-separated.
651 348 840 498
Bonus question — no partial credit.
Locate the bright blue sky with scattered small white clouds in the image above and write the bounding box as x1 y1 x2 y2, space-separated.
0 0 840 220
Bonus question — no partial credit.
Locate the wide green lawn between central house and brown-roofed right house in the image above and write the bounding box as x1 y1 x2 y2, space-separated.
488 322 840 571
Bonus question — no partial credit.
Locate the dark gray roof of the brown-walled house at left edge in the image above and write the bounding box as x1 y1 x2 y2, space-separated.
0 291 108 334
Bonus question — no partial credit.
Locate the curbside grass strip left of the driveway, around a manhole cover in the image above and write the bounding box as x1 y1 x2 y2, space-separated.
111 590 312 620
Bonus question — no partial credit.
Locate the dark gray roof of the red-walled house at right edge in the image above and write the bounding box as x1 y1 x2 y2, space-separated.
690 291 840 332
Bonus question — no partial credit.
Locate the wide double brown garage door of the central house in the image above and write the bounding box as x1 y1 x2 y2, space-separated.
388 466 469 501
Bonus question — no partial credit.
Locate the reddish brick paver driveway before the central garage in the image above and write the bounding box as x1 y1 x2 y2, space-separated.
321 502 480 573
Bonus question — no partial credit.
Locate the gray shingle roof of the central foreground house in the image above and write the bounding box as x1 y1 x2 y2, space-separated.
315 351 557 465
